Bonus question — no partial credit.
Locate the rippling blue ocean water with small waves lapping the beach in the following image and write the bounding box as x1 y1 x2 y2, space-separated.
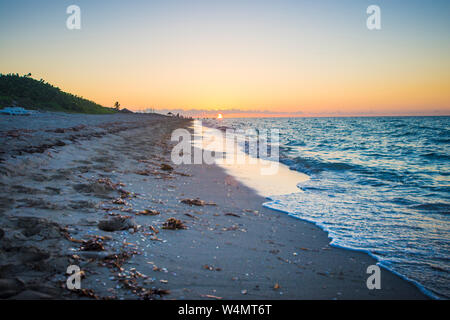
207 117 450 299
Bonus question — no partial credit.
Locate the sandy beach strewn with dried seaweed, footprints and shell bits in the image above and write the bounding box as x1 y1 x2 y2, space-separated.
0 113 427 300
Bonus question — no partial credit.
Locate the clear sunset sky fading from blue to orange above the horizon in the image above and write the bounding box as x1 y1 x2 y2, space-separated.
0 0 450 116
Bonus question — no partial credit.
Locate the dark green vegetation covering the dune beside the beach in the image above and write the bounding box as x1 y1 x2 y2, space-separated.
0 73 117 114
